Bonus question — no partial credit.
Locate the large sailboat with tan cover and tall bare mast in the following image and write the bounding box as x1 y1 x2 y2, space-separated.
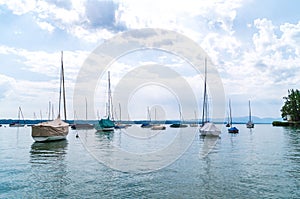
31 52 69 142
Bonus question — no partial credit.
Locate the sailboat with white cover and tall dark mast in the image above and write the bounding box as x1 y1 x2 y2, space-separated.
199 58 221 136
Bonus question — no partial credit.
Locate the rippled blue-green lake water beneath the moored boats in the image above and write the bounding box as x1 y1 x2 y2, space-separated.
0 124 300 198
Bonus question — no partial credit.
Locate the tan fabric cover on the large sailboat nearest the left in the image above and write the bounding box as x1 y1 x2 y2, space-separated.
31 117 69 137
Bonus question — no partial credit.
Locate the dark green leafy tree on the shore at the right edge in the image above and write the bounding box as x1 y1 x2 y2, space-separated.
280 89 300 122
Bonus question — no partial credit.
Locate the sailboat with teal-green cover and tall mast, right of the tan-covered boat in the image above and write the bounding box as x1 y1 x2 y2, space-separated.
95 71 115 131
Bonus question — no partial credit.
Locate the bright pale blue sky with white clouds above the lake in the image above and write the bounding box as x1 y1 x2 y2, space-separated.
0 0 300 119
